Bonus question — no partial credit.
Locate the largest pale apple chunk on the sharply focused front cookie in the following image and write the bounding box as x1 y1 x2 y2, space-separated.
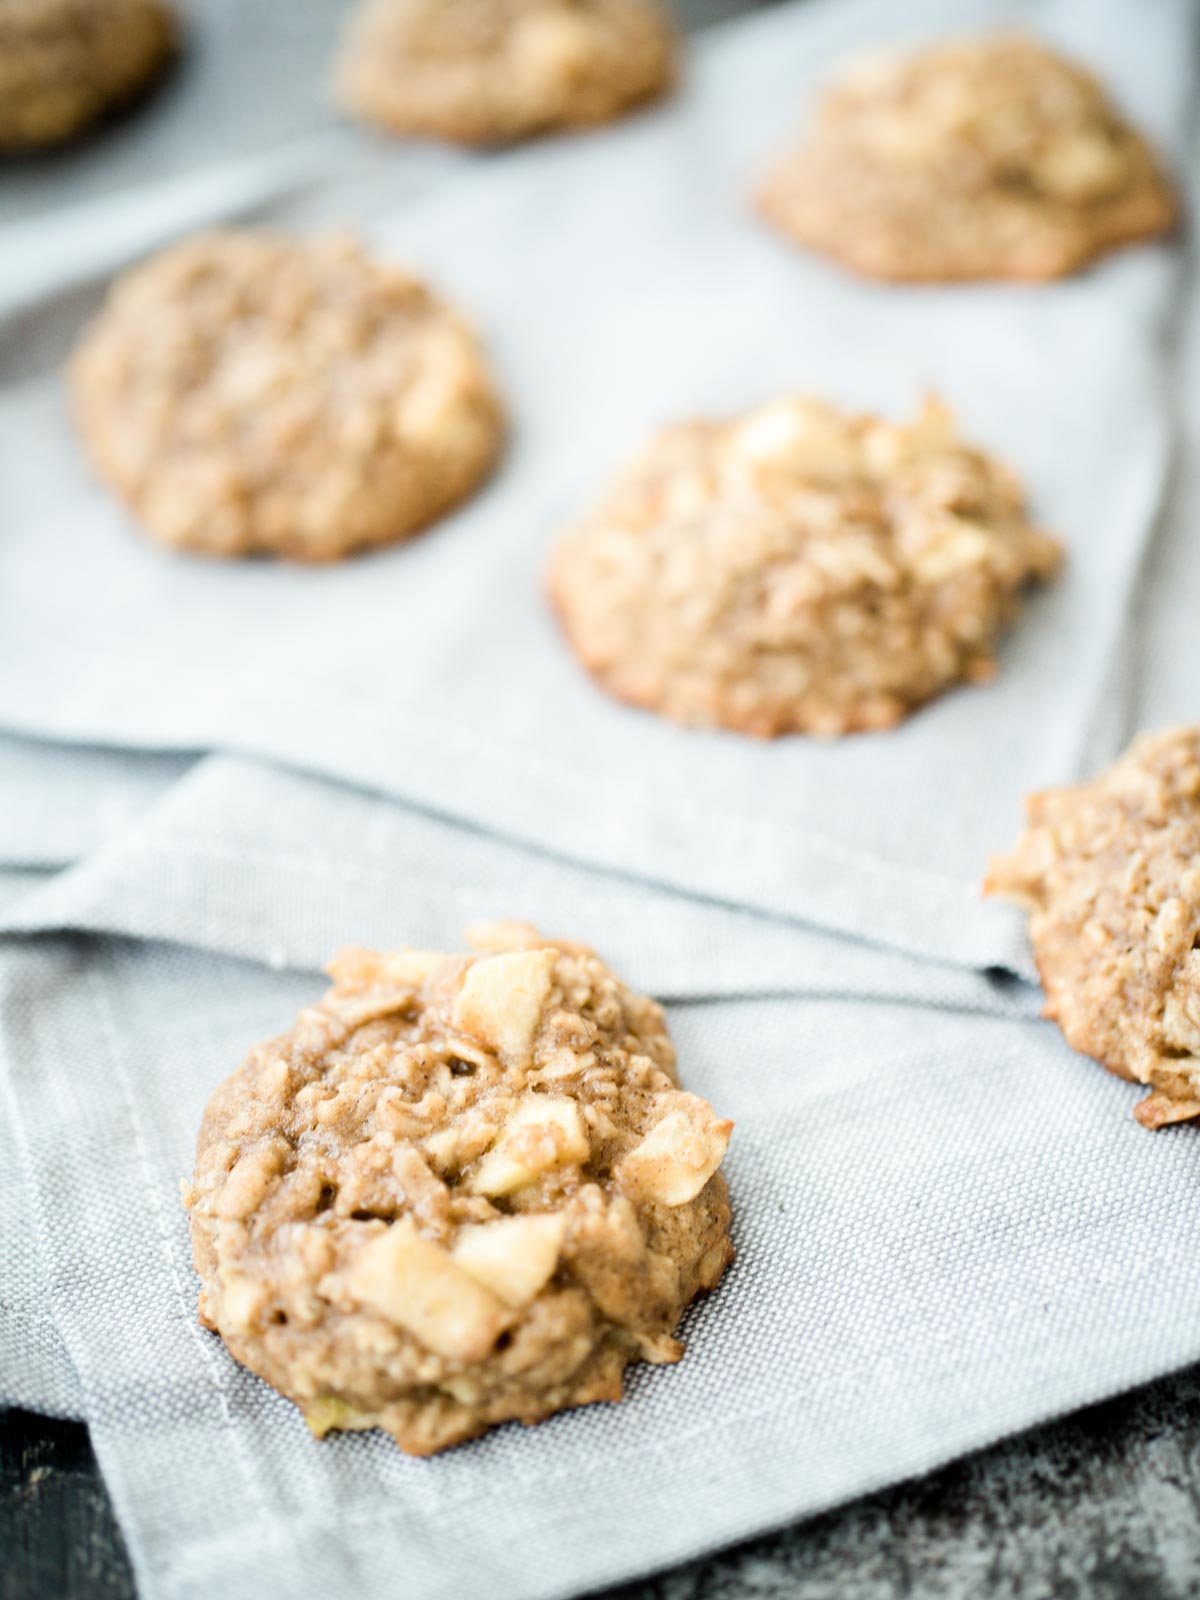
342 1218 512 1362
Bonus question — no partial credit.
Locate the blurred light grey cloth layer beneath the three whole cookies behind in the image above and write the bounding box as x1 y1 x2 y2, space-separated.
0 0 1194 965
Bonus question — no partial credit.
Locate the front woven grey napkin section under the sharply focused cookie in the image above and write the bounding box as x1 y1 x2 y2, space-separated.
0 934 1200 1600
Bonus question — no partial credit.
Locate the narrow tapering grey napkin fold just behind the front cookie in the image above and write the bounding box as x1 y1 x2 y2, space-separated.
0 755 1034 1016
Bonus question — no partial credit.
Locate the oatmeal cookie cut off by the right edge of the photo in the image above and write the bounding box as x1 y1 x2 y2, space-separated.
984 728 1200 1128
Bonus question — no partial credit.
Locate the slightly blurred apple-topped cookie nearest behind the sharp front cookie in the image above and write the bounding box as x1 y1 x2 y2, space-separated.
549 398 1061 738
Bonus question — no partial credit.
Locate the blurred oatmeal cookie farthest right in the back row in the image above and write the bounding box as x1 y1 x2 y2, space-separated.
758 37 1178 282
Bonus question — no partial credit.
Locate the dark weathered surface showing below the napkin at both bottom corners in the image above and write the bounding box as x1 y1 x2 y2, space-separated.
0 1371 1200 1600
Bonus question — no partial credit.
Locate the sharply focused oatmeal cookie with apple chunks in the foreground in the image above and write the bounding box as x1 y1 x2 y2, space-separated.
184 923 733 1456
